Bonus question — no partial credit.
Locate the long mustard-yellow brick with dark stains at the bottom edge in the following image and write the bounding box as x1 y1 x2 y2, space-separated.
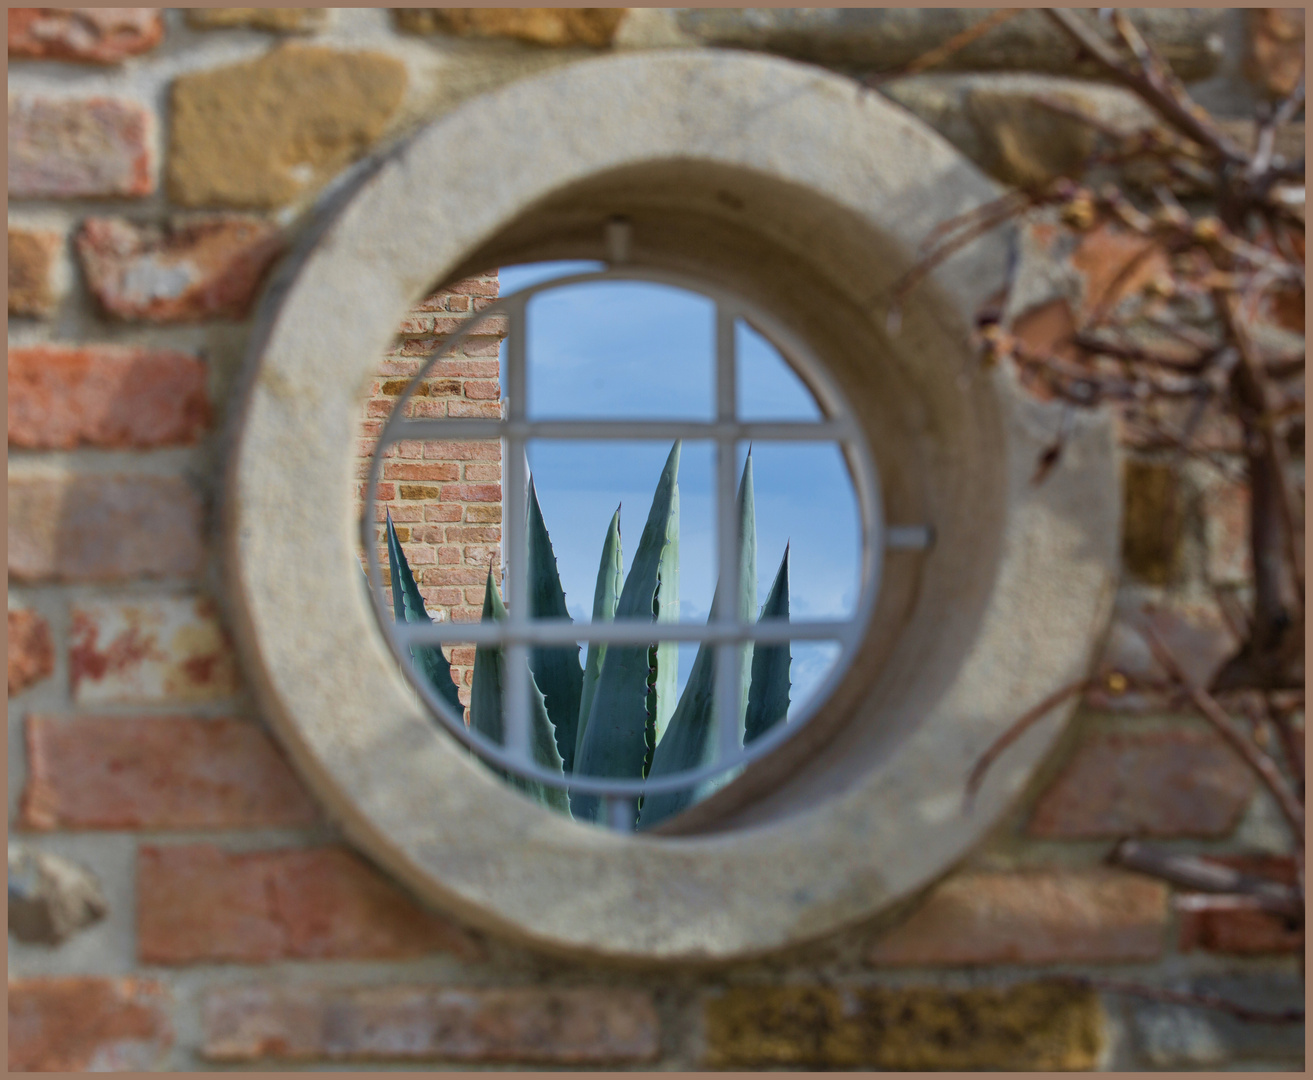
705 982 1107 1071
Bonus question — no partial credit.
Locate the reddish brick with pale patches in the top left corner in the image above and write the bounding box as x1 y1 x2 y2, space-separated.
9 8 164 64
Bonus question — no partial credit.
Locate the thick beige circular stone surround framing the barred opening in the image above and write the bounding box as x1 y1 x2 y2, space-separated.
225 50 1120 962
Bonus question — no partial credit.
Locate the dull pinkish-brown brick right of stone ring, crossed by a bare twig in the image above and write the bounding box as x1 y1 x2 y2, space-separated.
1086 600 1238 713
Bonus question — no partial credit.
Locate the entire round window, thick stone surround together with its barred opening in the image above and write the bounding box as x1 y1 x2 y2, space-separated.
226 50 1120 961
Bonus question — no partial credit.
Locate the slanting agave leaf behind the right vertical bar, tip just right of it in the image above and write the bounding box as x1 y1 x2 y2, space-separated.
641 450 756 828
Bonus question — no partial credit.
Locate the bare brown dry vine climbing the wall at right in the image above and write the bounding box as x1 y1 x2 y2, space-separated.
892 9 1305 1022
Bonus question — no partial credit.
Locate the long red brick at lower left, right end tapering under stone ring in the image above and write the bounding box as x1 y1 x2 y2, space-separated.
137 844 482 965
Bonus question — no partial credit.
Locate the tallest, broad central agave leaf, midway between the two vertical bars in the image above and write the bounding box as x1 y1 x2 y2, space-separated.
571 442 680 820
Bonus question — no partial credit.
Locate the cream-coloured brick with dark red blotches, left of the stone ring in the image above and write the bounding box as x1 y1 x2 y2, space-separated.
68 597 238 705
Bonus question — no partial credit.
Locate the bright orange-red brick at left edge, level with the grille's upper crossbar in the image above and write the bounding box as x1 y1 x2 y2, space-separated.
9 345 210 450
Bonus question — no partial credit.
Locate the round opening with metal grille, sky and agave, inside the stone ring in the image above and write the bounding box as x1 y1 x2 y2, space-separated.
362 249 930 831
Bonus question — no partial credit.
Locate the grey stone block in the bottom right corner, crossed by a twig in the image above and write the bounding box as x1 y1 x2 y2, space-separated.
1127 972 1304 1070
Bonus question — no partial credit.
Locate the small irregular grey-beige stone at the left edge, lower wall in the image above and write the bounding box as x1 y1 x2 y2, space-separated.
9 844 109 945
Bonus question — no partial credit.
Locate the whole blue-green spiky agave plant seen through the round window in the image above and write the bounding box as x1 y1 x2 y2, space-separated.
387 442 792 828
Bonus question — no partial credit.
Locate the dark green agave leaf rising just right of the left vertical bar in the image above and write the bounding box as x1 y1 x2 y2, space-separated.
528 478 583 773
